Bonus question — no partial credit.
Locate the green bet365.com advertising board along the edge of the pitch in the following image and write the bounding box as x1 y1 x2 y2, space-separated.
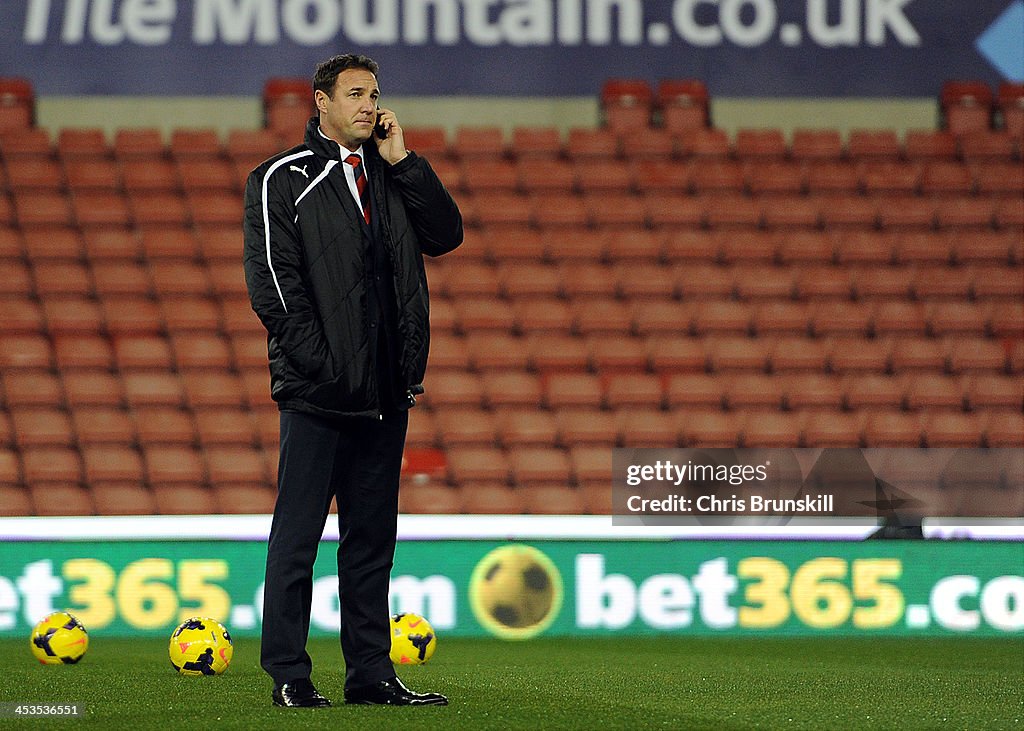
0 540 1024 640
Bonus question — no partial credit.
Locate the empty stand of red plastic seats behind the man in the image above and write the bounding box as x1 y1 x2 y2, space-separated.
0 75 1024 514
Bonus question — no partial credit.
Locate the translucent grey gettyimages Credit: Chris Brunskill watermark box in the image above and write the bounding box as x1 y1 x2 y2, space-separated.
611 448 1024 525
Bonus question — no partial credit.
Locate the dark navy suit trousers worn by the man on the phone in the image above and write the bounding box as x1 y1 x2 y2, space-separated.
260 412 409 688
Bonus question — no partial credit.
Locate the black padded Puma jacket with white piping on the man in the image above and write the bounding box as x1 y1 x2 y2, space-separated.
244 117 463 417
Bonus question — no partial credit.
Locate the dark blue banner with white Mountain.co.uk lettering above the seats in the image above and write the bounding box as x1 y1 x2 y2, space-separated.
0 0 1024 97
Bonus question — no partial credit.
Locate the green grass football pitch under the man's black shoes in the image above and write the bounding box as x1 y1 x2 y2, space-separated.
0 635 1024 731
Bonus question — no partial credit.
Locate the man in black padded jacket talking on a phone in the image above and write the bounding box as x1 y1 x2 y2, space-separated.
244 54 463 707
